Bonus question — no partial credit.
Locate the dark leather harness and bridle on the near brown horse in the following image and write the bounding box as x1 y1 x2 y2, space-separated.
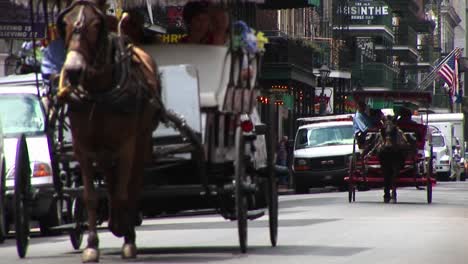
57 0 161 115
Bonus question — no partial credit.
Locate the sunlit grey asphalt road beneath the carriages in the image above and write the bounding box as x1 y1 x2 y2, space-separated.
0 182 468 264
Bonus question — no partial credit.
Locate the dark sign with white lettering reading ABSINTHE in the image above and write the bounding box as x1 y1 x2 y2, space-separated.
337 0 390 20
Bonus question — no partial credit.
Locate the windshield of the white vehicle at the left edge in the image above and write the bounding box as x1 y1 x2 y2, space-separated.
0 94 45 136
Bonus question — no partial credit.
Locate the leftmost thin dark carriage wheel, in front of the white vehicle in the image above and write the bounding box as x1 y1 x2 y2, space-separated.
14 135 31 258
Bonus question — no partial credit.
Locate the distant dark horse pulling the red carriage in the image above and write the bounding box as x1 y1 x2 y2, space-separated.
368 116 416 203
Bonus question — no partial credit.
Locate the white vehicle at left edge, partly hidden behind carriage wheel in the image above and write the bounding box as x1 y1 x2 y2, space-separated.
0 74 62 234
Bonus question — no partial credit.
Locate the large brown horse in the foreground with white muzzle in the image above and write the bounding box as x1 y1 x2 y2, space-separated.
57 0 162 262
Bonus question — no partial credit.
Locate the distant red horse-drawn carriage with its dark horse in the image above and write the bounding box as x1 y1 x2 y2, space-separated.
345 91 435 203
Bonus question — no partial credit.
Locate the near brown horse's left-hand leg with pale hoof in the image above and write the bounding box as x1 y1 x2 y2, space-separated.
80 159 100 263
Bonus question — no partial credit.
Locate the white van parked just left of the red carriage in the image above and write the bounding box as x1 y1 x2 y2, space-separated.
292 115 354 193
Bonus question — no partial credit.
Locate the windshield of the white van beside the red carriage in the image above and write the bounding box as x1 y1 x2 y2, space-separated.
296 125 353 149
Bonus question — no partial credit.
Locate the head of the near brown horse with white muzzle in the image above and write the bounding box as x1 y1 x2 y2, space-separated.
57 0 108 86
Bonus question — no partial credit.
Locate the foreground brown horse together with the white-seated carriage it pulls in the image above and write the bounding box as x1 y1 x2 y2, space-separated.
10 0 278 262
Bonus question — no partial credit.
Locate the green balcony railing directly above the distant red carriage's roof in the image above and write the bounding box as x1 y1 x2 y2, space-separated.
352 62 397 89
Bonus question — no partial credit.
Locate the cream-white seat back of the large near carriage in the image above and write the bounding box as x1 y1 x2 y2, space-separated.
143 44 231 109
